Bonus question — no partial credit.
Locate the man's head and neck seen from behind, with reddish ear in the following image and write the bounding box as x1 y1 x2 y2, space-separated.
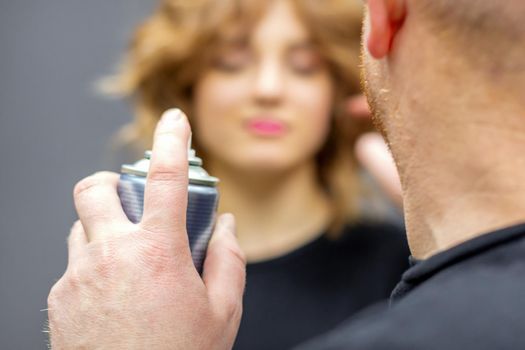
363 0 525 258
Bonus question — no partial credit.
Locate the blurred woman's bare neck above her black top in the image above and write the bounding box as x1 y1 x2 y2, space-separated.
208 162 331 261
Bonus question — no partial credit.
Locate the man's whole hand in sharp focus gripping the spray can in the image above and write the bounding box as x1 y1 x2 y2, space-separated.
48 110 245 350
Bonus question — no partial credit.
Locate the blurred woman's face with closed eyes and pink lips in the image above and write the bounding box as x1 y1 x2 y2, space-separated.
194 1 333 172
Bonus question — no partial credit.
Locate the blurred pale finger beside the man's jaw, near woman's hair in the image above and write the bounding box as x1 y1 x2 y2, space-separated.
355 133 403 207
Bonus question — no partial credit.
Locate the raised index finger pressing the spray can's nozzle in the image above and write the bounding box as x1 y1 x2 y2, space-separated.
141 109 190 243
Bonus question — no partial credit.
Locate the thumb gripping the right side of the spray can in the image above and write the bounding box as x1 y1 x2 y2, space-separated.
203 214 246 316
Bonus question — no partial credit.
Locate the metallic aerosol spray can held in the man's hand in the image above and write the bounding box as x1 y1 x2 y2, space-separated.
118 147 219 273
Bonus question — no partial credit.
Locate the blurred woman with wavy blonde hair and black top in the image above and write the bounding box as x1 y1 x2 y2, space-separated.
106 0 408 349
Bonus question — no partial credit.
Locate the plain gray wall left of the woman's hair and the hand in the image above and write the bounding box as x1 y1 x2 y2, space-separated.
0 0 155 349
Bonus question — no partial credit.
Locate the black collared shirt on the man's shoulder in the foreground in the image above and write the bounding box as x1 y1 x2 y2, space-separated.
298 225 525 350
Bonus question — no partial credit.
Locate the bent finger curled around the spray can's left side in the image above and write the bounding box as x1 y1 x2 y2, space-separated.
74 172 129 241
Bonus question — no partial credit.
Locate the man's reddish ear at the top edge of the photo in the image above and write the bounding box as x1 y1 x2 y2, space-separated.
366 0 406 59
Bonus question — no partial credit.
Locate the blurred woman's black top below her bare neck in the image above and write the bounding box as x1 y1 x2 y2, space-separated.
234 224 409 350
